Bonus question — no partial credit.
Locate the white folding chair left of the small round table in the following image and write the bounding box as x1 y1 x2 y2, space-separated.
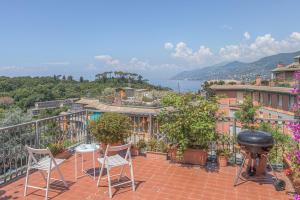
24 146 68 200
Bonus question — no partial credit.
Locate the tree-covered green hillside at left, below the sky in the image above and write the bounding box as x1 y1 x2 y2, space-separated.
0 71 167 124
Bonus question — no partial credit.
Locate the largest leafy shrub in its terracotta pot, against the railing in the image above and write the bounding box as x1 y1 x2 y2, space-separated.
159 93 218 165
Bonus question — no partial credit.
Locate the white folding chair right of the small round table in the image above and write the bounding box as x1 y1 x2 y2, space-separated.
97 143 135 198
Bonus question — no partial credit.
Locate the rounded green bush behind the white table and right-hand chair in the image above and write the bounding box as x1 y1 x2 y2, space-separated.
90 112 132 149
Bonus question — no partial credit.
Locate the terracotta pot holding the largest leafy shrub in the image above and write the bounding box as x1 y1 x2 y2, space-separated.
183 149 208 166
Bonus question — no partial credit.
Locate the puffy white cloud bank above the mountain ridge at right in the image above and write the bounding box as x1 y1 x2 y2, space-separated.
165 32 300 66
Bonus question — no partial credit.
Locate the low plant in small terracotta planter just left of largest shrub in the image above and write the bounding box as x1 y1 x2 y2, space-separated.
146 138 167 160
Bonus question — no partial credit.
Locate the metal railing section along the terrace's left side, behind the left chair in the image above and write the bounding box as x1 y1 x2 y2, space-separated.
0 111 87 184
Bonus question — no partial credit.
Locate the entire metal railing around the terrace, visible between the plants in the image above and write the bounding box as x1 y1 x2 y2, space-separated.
0 110 296 185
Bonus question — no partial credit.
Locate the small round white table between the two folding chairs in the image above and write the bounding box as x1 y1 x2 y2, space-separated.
75 144 100 180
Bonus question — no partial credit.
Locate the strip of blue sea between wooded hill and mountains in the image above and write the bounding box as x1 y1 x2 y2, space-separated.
149 79 203 92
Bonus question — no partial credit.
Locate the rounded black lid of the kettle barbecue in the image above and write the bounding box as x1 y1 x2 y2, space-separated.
237 130 274 147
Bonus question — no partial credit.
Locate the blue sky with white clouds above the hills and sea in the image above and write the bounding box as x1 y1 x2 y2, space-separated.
0 0 300 79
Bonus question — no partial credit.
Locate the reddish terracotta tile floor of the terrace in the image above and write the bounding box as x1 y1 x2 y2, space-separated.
0 153 293 200
